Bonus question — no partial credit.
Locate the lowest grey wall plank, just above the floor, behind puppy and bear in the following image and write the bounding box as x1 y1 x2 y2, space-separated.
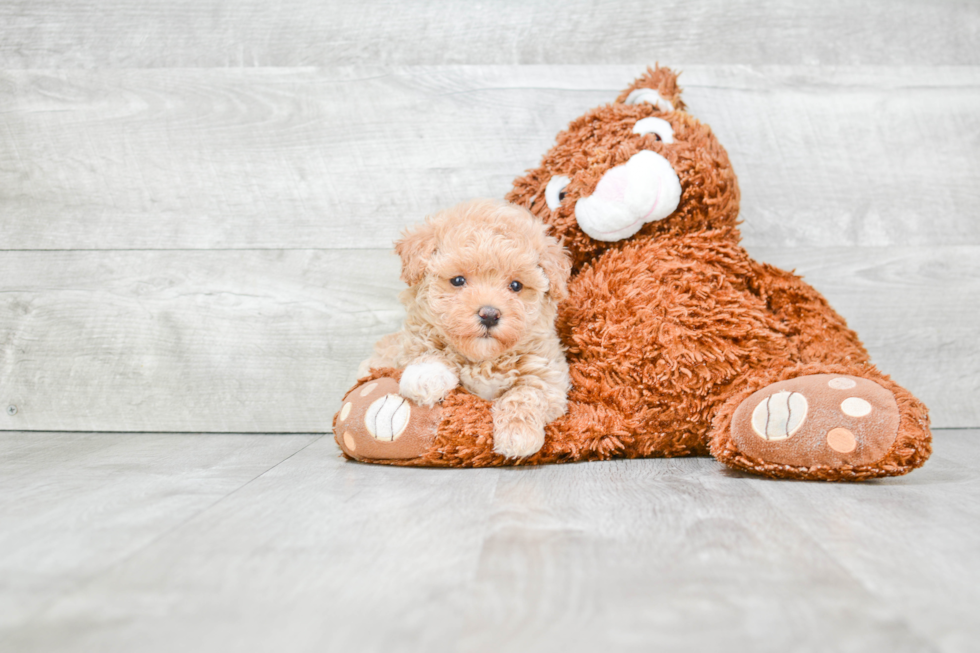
0 246 980 432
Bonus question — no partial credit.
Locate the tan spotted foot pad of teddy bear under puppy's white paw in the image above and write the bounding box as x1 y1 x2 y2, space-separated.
334 377 441 460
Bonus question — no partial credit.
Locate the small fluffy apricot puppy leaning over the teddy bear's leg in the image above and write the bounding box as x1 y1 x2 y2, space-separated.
359 200 571 458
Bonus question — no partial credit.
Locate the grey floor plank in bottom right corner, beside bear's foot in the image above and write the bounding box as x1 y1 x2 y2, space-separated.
752 444 980 651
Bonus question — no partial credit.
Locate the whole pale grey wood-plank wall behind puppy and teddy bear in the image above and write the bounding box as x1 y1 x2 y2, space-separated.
0 0 980 432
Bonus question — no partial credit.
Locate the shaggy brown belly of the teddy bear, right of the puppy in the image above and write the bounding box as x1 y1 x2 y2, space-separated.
559 237 795 426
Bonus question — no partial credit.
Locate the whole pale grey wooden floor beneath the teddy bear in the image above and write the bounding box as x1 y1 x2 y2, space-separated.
0 430 980 653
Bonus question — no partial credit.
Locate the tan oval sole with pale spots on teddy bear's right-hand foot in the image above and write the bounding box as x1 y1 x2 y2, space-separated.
731 374 899 468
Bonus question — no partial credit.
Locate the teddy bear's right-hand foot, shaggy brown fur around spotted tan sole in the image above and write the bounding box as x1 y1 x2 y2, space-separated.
710 363 931 481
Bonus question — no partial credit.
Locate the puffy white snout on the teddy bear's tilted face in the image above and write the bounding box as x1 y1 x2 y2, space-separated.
575 150 681 242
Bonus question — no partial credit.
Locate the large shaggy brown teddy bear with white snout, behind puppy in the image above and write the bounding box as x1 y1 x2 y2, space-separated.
334 67 931 480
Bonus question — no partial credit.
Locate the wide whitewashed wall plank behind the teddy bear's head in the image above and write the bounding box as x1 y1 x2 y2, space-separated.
0 66 980 249
